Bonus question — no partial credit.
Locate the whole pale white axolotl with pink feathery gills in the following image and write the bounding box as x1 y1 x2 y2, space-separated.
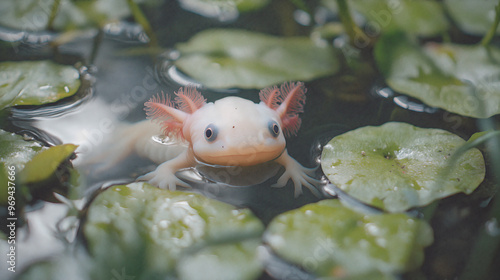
95 82 318 196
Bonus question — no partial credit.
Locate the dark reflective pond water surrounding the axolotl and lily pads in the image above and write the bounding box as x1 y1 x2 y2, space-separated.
0 1 500 279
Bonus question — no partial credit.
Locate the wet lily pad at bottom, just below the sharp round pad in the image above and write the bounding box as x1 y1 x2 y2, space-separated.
265 199 433 279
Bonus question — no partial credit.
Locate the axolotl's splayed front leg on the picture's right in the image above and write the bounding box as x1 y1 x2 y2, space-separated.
272 150 320 197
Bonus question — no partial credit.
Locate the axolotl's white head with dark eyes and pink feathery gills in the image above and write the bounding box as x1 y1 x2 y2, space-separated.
145 82 306 166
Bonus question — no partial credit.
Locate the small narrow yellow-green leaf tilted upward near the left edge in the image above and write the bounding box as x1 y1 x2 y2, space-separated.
19 144 78 183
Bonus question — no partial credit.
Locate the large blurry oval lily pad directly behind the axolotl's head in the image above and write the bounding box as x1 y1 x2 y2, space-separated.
174 29 339 88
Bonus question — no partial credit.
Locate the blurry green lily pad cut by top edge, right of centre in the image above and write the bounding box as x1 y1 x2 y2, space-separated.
349 0 448 36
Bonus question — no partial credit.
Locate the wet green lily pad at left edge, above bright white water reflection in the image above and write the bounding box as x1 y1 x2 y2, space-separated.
0 60 80 109
